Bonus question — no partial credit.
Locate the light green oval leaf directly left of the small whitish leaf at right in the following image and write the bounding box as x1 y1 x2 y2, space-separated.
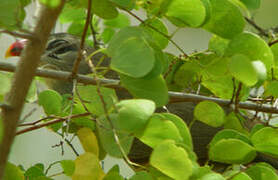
228 54 258 86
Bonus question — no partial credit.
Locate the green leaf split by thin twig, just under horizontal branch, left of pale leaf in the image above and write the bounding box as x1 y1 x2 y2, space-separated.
78 85 117 116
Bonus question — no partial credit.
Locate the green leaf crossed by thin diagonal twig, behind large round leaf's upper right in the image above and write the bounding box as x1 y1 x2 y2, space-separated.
141 18 169 49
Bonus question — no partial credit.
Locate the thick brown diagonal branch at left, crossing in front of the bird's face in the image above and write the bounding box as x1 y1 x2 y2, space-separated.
0 0 65 179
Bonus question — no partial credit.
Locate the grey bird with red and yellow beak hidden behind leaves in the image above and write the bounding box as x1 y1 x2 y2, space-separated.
5 33 278 167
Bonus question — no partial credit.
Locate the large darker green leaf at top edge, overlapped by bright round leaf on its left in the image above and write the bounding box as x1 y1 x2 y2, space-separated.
203 0 245 39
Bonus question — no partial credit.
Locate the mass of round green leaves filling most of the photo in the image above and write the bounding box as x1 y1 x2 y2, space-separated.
0 0 278 180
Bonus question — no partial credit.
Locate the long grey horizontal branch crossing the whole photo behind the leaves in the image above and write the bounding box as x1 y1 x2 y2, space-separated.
0 62 278 114
